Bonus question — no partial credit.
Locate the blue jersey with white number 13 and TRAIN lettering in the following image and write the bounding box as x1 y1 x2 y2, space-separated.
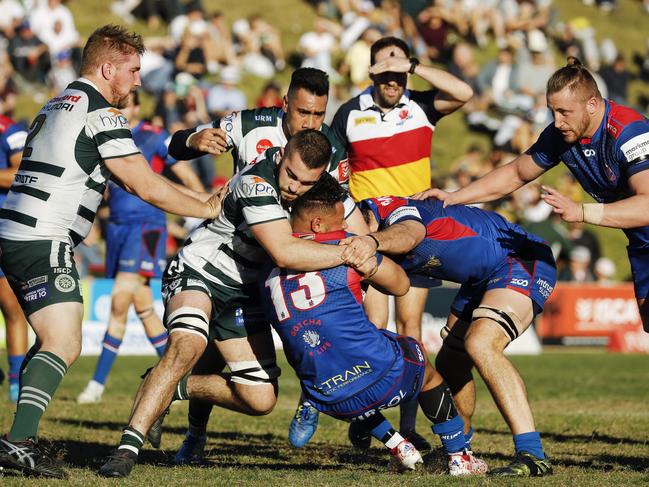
261 231 401 404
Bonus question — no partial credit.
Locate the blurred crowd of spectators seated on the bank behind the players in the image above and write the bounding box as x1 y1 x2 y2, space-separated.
0 0 649 284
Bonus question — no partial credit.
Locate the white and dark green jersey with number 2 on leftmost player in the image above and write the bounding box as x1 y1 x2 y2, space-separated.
0 78 140 247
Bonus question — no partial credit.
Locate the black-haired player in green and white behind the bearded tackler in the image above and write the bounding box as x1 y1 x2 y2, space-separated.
167 68 369 454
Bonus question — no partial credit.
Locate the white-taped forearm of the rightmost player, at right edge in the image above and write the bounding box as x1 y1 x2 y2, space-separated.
584 194 649 228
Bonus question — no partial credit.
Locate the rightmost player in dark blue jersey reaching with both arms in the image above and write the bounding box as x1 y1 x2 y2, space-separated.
419 57 649 332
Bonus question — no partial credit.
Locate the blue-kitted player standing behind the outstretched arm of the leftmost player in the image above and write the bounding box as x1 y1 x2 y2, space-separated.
77 92 204 404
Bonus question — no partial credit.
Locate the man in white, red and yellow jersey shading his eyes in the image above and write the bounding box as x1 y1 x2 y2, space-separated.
331 37 473 449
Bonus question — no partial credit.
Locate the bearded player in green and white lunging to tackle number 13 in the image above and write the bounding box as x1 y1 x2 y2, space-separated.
99 129 376 477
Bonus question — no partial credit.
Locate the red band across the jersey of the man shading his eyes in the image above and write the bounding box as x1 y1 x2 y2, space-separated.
348 127 433 172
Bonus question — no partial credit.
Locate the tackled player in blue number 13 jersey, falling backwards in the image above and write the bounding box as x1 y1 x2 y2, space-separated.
258 177 487 475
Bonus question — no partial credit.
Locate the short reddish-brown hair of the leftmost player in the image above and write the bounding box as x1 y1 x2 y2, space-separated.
81 24 145 74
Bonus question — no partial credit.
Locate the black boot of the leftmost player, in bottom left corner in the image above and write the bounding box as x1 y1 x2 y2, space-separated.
0 436 68 479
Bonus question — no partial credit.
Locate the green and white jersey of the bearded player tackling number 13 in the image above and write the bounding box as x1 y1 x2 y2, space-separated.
178 147 289 288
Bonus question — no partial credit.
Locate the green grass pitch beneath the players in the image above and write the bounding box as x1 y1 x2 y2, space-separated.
0 351 649 487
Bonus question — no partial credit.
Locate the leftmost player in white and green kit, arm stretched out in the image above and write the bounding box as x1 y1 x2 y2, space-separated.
0 25 221 478
